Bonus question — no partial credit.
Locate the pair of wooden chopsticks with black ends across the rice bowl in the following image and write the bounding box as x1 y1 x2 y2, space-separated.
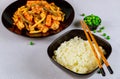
80 21 113 76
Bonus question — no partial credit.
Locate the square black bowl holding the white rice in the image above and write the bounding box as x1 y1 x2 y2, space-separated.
47 29 112 77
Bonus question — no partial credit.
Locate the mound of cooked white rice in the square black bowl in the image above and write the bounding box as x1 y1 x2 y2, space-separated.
53 36 104 74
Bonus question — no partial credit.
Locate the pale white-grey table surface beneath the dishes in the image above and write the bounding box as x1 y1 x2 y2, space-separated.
0 0 120 79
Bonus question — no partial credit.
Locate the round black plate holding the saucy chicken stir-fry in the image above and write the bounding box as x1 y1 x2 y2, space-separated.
2 0 74 37
